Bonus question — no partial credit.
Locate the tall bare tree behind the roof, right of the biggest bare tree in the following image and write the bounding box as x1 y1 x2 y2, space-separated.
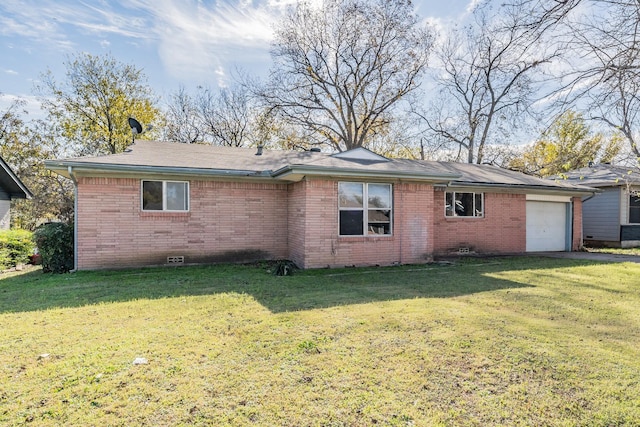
418 6 560 164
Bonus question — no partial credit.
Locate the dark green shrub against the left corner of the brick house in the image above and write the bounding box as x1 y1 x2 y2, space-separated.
34 222 73 273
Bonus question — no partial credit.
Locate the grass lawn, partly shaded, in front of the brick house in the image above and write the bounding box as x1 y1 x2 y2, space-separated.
0 257 640 426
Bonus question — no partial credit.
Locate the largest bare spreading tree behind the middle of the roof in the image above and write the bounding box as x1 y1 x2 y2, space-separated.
259 0 433 151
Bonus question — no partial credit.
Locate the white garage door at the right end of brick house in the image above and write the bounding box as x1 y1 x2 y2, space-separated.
527 201 567 252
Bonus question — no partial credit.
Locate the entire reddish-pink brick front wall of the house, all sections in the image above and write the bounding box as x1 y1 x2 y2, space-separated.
77 178 582 269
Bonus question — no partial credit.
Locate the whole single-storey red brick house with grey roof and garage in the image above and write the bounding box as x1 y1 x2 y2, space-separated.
46 141 593 269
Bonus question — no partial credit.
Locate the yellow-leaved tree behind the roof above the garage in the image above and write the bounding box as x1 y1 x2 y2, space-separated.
509 111 621 177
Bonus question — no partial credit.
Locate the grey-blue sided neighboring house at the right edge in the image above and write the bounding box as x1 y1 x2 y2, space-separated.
554 164 640 248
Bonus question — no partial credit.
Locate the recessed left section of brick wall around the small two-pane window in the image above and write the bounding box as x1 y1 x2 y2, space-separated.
76 177 288 269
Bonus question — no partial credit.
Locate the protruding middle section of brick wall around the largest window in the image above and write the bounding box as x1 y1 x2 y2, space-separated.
289 180 433 268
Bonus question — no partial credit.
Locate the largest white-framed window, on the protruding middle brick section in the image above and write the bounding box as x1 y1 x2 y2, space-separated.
338 182 392 236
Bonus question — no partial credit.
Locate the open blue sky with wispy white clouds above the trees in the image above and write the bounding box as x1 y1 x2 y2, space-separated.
0 0 478 118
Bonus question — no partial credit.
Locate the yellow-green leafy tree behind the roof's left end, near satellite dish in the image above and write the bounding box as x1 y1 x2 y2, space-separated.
36 53 160 155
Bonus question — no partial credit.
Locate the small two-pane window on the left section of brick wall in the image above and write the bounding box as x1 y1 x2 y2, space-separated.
142 181 189 211
